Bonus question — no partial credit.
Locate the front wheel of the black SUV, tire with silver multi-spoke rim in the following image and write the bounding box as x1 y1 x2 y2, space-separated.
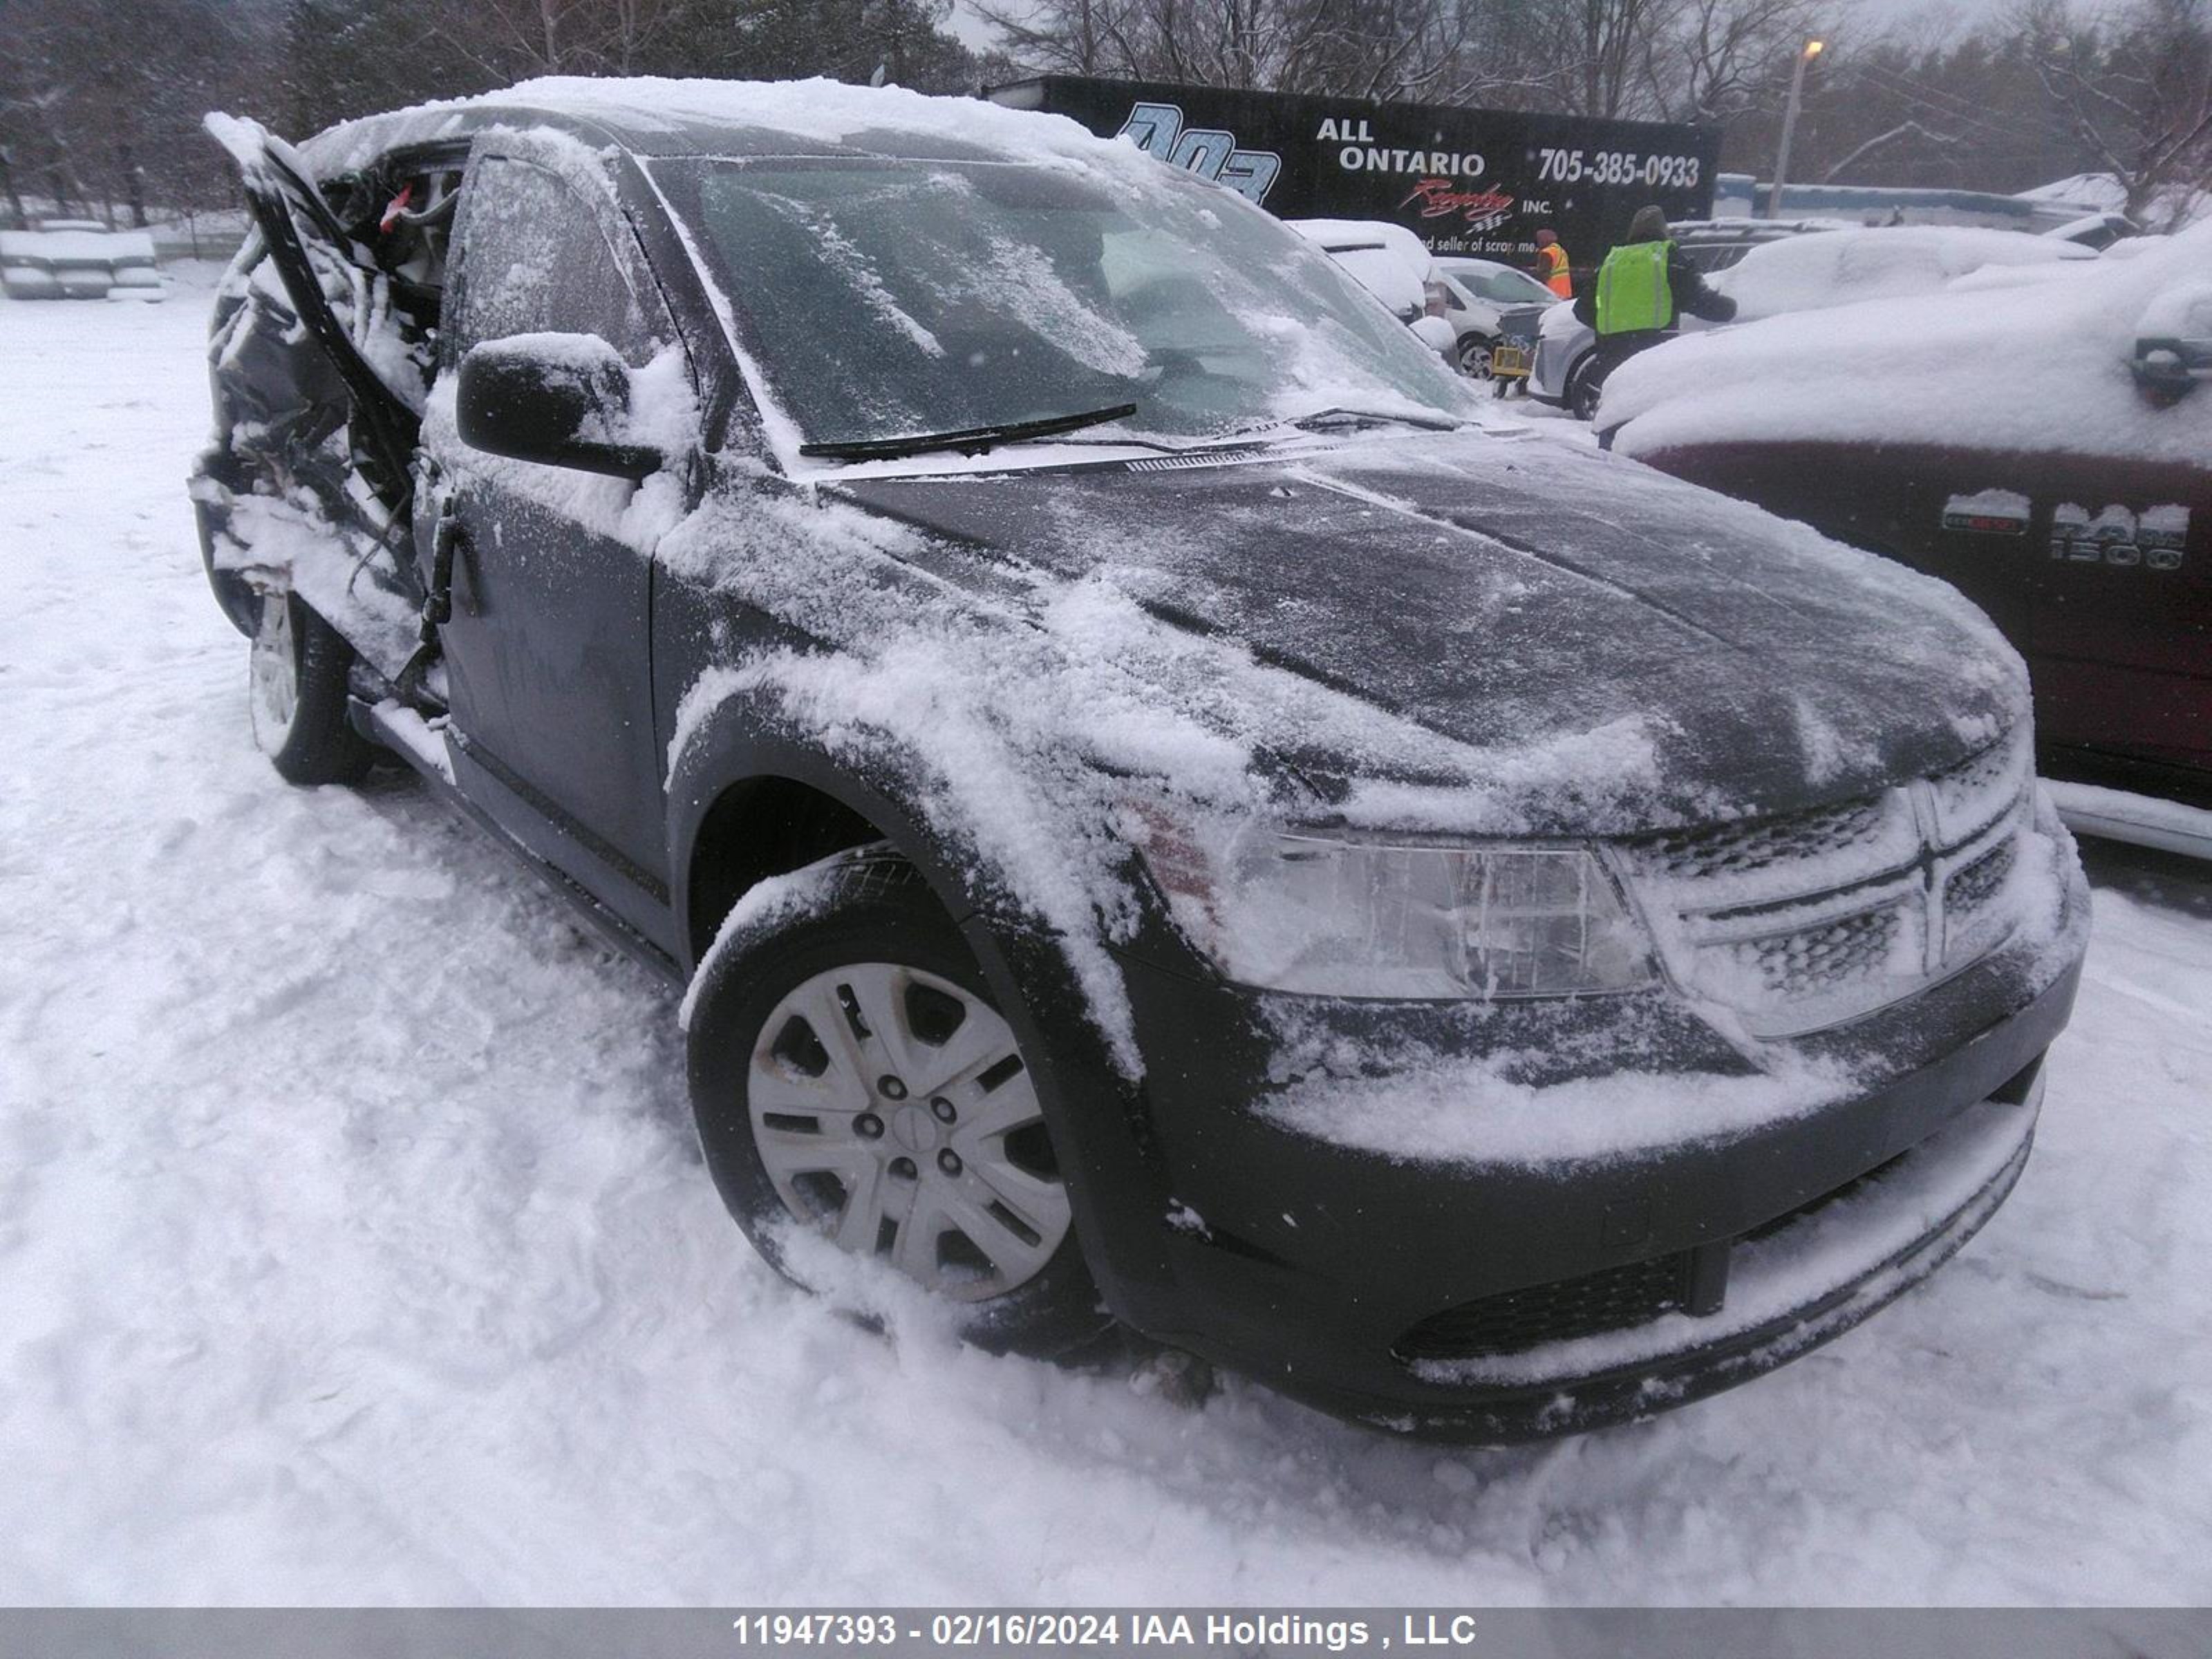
688 845 1113 1358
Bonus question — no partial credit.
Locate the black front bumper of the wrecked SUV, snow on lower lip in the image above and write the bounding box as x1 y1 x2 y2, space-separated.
1099 849 2086 1442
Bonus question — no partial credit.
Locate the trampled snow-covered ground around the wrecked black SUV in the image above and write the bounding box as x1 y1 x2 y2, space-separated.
0 272 2212 1604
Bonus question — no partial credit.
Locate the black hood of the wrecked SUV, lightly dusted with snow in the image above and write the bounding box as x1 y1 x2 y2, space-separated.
838 431 2026 834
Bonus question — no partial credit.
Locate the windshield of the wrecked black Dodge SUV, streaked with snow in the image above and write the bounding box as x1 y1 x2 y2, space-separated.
655 157 1467 456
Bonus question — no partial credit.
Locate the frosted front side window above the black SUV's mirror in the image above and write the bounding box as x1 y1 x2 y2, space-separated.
444 157 675 365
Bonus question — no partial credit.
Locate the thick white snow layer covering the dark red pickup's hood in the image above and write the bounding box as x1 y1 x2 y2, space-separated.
1604 225 2212 467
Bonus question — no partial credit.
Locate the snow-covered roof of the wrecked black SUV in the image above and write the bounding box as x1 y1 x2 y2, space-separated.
301 75 1141 175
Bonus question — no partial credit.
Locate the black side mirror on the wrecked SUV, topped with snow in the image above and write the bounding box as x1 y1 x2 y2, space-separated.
453 334 664 478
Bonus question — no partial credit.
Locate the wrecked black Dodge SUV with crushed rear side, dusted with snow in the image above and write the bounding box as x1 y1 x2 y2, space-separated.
192 79 2086 1440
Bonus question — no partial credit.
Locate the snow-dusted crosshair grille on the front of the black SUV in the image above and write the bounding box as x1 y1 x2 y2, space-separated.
1619 734 2033 1038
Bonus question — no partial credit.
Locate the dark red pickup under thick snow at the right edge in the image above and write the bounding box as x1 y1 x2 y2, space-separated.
1600 225 2212 850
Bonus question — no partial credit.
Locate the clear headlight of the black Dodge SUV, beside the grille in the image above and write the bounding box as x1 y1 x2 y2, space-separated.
1128 805 1657 1000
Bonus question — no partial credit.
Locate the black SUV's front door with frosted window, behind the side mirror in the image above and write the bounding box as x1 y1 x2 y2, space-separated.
416 140 690 940
